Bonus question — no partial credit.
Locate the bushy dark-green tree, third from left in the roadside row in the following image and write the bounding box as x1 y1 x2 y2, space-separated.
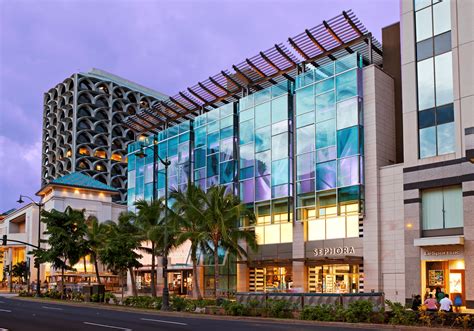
98 212 142 301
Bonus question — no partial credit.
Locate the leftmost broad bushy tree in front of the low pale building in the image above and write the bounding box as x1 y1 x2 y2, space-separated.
33 207 86 299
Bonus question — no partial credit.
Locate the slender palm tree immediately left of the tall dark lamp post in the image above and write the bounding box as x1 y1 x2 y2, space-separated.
135 199 165 297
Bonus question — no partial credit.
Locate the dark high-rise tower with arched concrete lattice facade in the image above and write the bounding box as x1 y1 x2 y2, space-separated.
41 69 166 202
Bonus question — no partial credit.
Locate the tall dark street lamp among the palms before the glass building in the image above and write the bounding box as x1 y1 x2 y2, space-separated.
135 139 171 310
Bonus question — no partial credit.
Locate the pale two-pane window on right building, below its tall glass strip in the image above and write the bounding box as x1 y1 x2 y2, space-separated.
421 185 464 235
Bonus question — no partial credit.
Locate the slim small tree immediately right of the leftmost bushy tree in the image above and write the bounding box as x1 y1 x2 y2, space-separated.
84 216 108 285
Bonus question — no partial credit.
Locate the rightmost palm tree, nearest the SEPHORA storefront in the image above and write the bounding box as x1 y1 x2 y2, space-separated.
205 186 257 297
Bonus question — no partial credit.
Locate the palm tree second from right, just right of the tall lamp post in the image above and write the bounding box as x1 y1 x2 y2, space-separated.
170 185 208 299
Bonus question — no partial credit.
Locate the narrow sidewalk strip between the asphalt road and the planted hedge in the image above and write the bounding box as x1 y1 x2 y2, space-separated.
12 297 452 331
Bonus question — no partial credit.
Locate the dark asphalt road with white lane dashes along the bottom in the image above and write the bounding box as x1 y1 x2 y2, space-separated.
0 296 374 331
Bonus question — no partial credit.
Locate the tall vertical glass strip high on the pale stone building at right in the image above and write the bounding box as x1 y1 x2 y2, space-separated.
415 0 455 158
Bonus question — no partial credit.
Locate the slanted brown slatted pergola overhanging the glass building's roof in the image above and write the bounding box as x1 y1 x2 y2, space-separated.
125 10 383 133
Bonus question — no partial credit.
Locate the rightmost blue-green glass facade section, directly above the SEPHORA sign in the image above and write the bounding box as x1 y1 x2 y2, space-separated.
295 54 364 240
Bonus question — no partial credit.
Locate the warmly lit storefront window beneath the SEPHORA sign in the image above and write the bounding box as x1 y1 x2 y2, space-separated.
308 264 359 293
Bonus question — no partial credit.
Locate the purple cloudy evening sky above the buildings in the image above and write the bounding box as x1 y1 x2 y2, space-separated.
0 0 400 212
